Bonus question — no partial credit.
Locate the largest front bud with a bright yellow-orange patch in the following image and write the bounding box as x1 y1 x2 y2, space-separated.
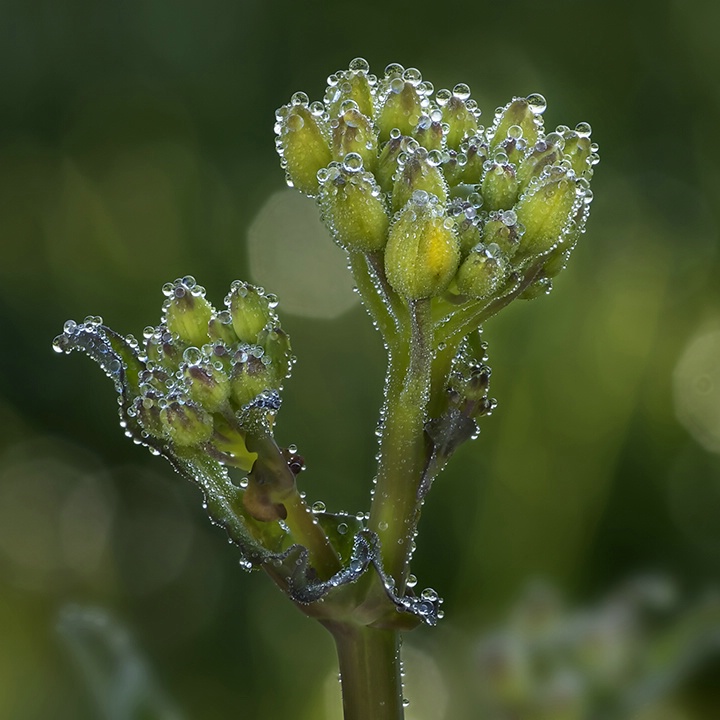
385 190 460 300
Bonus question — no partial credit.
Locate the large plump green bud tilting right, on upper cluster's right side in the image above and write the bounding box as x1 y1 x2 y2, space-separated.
515 167 578 255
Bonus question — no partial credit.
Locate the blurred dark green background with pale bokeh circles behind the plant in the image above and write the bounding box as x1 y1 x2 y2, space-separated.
0 0 720 720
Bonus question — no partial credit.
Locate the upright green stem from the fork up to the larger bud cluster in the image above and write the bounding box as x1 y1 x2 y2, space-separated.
369 300 432 593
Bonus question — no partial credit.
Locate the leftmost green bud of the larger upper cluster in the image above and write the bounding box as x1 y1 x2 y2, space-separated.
275 93 332 195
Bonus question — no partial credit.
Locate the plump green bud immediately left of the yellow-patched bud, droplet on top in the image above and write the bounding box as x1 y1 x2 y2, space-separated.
318 159 390 252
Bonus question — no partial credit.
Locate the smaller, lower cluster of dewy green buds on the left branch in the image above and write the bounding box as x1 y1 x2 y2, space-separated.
55 276 294 470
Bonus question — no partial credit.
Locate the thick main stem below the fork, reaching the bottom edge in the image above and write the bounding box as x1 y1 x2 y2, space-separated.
325 622 404 720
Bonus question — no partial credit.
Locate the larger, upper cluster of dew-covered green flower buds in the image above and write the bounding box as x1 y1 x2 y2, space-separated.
275 58 598 300
